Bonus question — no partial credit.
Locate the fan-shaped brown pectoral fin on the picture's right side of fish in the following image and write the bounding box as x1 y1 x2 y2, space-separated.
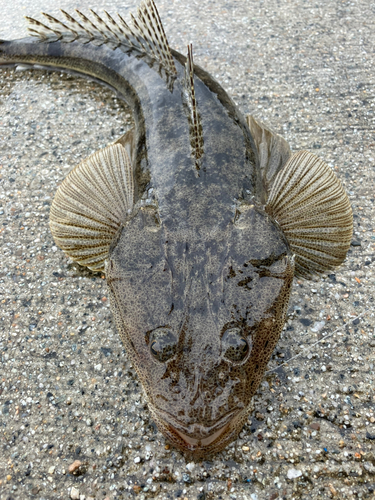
266 151 353 278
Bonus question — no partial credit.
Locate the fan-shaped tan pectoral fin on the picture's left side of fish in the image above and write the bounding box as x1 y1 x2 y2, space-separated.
50 138 134 271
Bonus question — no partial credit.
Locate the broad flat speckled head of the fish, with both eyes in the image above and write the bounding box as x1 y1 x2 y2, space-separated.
106 206 294 458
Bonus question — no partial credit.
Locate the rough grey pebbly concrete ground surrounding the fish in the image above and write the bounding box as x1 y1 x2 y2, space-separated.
0 0 375 500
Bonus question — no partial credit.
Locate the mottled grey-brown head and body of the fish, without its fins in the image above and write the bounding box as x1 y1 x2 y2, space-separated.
0 1 352 459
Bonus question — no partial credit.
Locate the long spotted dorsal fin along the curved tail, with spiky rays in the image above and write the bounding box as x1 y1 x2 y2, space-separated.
26 0 177 76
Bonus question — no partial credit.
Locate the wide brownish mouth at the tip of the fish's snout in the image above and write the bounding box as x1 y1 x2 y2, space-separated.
149 404 248 459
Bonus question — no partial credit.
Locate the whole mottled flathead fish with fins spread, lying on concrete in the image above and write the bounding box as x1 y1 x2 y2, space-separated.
0 0 352 458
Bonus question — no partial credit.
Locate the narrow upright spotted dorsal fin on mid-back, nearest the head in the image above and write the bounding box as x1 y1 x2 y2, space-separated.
183 44 204 170
